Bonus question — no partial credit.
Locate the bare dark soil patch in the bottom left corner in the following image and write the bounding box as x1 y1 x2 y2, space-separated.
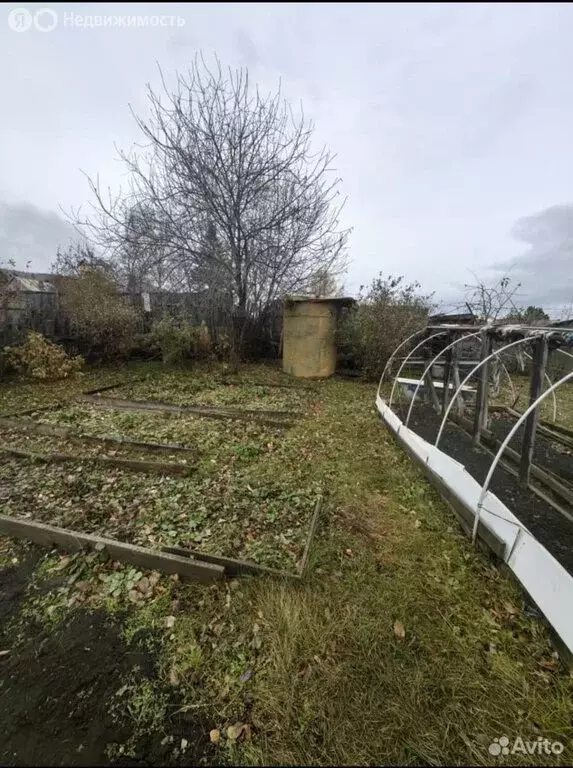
0 551 212 766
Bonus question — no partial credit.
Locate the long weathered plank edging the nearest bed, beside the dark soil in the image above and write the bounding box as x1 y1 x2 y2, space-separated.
0 515 224 584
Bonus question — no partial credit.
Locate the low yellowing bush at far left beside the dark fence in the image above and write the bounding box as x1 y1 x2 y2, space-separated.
4 331 84 380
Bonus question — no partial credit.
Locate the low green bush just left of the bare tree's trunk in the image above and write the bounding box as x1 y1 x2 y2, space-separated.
147 315 213 365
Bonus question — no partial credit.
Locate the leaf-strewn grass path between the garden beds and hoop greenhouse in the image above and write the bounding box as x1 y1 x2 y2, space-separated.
1 364 573 765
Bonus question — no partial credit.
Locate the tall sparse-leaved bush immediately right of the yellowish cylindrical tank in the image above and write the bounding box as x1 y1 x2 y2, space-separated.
339 273 432 379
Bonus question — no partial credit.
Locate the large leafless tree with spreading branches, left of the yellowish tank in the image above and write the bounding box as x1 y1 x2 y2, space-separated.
73 57 348 360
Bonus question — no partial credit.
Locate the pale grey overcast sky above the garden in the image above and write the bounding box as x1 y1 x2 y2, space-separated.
0 3 573 314
